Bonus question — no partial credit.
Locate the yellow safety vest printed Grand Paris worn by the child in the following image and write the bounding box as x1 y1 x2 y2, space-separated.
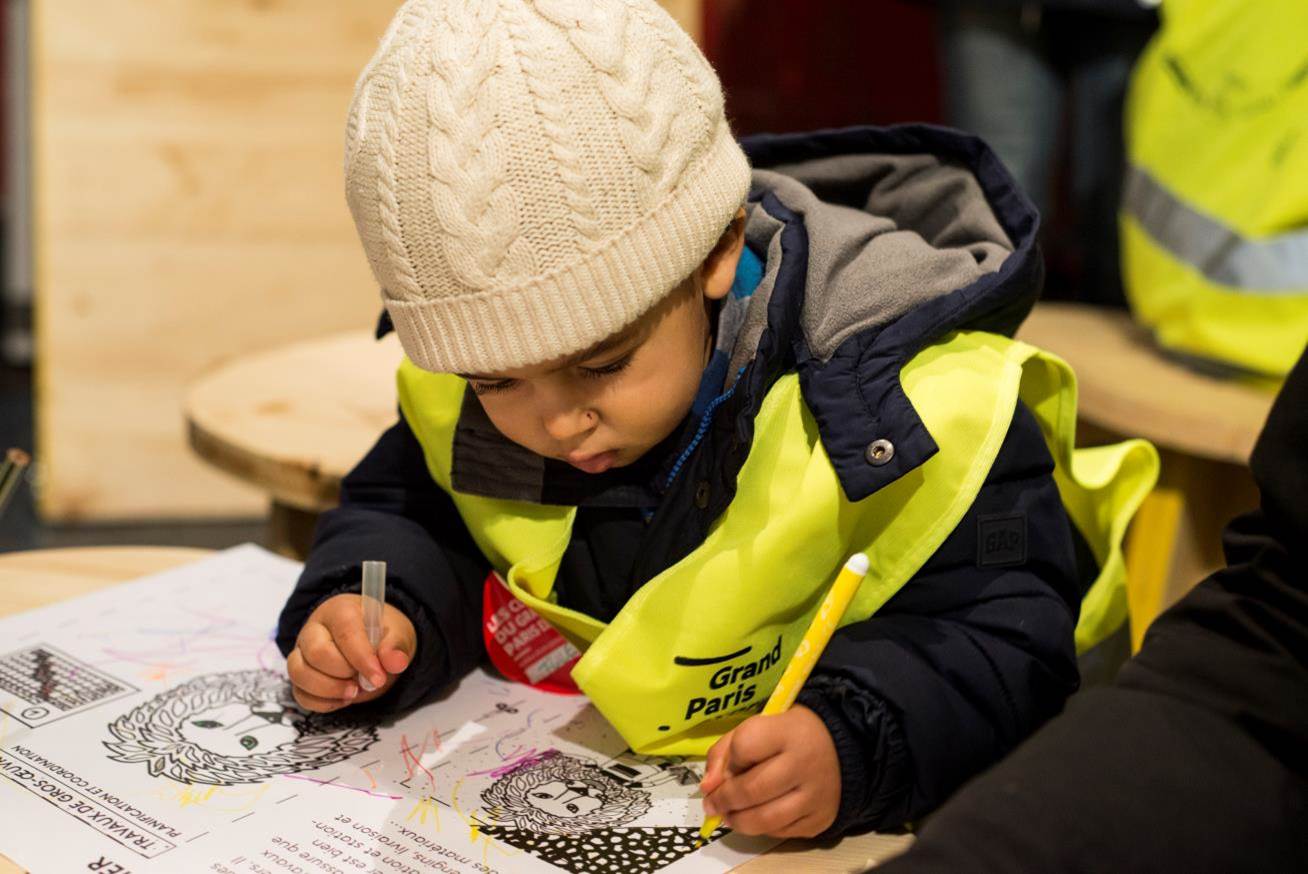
399 331 1158 755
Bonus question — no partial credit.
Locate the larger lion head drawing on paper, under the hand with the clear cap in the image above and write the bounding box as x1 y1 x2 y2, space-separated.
105 670 377 786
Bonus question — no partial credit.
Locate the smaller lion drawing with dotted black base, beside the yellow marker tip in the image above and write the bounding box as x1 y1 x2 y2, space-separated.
480 751 726 874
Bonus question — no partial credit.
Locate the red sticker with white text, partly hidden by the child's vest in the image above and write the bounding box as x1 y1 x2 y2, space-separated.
481 570 581 695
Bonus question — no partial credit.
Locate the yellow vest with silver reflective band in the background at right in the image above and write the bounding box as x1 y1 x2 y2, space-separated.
1120 0 1308 378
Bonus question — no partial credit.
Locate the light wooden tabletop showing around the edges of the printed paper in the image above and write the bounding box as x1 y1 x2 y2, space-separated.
0 547 913 874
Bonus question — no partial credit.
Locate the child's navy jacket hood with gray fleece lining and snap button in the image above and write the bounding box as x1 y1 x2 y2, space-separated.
730 126 1044 500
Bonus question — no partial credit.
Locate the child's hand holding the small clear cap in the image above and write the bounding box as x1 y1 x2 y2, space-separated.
286 594 417 713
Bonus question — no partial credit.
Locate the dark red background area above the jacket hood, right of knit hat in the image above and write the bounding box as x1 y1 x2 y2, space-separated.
702 0 940 135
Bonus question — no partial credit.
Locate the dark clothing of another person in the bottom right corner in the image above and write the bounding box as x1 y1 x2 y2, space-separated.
878 345 1308 874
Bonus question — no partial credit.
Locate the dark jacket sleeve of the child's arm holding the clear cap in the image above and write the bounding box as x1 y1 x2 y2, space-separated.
277 419 489 712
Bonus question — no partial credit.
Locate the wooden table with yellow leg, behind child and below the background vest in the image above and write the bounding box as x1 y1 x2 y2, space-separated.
1018 304 1275 646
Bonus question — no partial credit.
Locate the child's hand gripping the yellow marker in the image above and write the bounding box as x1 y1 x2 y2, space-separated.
700 704 840 837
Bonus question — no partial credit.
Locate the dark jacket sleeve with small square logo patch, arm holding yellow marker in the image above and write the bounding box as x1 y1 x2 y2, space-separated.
799 404 1080 833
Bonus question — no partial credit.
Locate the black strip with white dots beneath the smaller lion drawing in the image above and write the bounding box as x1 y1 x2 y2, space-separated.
481 826 727 874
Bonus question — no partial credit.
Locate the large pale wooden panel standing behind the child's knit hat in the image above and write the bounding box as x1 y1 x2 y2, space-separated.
30 0 698 521
